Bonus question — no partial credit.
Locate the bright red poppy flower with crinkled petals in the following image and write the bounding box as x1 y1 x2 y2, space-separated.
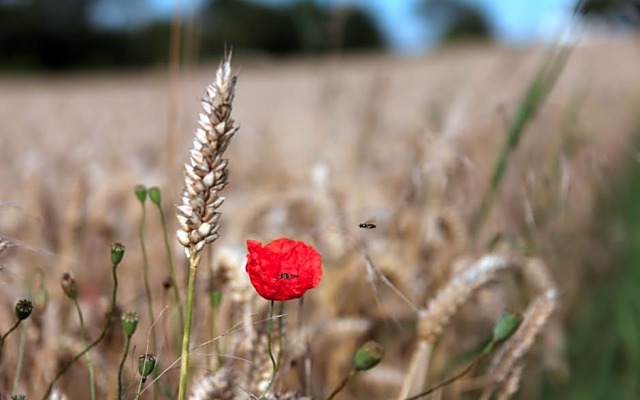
247 238 322 301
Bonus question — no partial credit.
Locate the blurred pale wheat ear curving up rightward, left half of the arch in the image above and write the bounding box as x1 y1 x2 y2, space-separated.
397 254 513 399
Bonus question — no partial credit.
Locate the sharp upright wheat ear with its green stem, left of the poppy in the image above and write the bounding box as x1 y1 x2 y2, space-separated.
177 53 238 400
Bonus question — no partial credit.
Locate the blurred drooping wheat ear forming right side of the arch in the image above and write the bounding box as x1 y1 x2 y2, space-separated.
482 289 558 400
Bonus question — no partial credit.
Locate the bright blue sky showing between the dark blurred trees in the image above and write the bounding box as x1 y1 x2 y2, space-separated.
111 0 575 52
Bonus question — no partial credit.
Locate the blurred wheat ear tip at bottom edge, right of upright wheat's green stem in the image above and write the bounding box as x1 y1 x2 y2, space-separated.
189 366 244 400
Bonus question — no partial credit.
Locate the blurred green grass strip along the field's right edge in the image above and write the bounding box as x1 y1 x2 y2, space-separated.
541 123 640 400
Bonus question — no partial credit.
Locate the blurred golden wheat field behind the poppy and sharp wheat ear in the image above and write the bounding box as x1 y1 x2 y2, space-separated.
0 39 640 399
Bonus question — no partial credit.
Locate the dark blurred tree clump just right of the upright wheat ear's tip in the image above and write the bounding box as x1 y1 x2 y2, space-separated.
202 0 383 55
